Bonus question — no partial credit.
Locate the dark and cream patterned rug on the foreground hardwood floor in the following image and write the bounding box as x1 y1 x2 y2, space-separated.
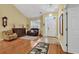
29 42 49 54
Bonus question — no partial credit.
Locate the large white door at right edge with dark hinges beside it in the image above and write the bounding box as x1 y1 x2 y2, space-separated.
68 7 79 53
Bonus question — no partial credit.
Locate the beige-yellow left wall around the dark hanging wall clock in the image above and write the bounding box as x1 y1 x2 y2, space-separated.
0 4 29 39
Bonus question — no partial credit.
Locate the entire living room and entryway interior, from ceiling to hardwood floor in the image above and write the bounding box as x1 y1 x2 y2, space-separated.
0 4 79 54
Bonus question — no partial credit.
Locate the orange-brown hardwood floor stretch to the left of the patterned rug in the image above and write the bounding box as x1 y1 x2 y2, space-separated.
0 39 32 54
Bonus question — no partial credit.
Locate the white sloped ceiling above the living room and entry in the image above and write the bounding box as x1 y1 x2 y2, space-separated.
14 4 58 17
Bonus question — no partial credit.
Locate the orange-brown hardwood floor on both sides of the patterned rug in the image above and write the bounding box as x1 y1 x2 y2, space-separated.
0 39 63 54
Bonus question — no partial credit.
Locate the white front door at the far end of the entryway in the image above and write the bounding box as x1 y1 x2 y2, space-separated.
44 16 56 36
